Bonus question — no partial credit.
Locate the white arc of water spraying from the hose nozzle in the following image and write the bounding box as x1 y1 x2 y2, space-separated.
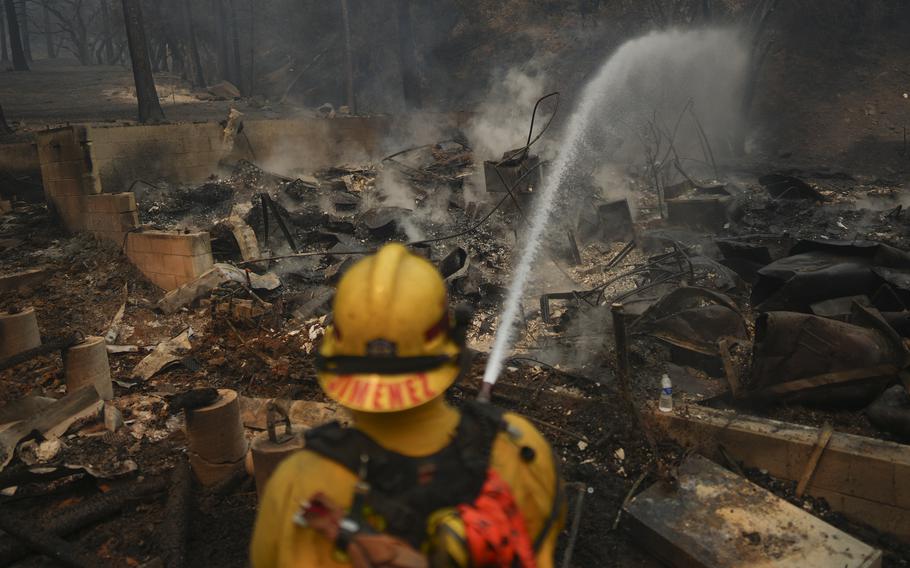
483 30 747 385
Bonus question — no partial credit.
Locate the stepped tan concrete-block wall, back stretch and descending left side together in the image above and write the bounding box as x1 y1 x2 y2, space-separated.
35 113 470 290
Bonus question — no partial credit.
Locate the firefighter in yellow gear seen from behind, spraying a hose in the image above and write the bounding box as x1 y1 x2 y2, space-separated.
251 244 565 568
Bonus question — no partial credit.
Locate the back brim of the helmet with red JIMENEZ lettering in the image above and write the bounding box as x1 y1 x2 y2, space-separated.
326 373 439 411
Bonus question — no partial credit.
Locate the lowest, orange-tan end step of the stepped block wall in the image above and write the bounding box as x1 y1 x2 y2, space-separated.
125 231 214 290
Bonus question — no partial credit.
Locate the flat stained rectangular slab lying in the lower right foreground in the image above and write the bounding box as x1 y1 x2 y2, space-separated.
625 455 882 568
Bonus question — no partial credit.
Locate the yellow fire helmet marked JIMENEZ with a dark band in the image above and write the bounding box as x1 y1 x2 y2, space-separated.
317 243 462 412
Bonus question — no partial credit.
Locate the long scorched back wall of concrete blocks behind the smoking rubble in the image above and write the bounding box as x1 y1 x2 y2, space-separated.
85 113 470 192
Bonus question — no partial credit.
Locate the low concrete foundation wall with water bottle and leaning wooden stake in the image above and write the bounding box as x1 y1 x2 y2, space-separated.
644 405 910 542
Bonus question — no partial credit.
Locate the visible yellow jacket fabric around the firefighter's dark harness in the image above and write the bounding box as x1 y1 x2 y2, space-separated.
251 400 565 568
